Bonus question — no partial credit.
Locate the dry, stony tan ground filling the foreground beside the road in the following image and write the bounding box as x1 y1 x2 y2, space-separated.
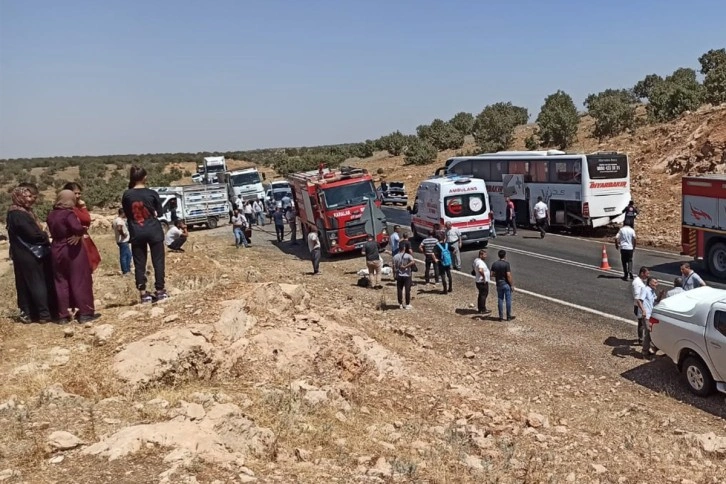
0 223 726 484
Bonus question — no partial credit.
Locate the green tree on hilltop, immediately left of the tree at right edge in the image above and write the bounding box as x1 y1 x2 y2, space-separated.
647 68 705 122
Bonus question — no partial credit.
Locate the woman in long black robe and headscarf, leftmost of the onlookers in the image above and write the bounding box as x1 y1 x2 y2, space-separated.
6 184 56 323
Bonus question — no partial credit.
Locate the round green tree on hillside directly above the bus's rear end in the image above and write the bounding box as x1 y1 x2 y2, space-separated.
584 89 637 140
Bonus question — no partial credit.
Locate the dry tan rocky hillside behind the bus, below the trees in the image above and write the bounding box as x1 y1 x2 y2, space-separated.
355 106 726 248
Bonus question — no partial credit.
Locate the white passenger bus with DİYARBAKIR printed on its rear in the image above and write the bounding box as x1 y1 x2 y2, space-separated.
436 150 630 227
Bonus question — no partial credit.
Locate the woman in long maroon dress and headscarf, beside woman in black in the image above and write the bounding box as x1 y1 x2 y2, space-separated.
48 190 98 323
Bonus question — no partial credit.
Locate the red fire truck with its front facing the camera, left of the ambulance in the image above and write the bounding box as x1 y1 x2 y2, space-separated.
288 166 388 254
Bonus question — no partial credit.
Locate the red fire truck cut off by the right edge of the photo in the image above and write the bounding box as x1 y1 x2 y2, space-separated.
681 175 726 279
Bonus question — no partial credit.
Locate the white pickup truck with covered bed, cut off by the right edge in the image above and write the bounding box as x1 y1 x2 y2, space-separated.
649 287 726 397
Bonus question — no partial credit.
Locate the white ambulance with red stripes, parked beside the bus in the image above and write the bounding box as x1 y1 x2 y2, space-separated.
409 175 490 245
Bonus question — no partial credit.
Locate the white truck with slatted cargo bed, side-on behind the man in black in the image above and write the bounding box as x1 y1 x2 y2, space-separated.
152 184 230 231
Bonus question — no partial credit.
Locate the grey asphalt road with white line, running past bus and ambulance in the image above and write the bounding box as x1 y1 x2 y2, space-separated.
383 207 726 320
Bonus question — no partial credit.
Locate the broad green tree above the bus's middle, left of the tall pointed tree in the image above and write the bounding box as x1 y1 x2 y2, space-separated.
474 102 529 151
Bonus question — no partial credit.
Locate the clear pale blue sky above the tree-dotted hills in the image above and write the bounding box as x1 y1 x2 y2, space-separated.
0 0 726 158
